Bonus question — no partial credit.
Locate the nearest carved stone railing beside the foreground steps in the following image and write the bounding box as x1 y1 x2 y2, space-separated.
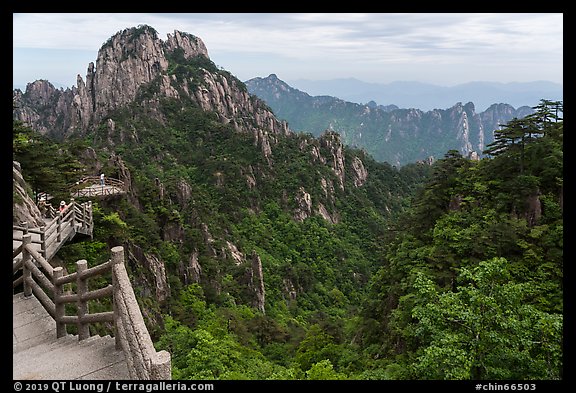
13 234 172 380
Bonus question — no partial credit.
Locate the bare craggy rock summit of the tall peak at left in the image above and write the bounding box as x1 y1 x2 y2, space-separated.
13 26 289 144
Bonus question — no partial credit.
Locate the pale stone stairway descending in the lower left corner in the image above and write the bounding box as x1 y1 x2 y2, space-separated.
12 293 130 380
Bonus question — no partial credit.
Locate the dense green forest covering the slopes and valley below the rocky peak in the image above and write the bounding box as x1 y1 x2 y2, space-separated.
13 31 563 380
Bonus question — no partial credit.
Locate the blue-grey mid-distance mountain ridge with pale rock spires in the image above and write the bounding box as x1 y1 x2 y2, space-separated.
245 74 532 165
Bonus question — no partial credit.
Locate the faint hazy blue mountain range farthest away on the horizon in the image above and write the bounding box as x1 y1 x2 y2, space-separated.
286 78 563 111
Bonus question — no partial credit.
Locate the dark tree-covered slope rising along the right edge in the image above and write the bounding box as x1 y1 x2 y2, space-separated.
361 101 563 379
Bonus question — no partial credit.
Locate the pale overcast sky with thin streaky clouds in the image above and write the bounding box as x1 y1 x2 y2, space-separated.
13 13 564 88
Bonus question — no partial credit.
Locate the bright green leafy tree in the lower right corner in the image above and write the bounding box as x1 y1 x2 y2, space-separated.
412 258 563 380
